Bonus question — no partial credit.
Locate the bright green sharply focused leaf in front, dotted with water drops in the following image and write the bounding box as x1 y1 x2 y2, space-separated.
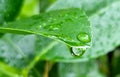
0 8 91 46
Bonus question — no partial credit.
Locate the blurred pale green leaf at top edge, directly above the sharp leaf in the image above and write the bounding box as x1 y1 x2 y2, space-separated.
47 0 119 16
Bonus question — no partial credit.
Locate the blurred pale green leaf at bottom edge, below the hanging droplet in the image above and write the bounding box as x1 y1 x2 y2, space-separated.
58 61 105 77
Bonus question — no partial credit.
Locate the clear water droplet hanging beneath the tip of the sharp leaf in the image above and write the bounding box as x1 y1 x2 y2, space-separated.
71 46 89 56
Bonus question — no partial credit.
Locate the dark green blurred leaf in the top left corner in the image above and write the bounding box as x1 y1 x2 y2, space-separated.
0 0 23 24
